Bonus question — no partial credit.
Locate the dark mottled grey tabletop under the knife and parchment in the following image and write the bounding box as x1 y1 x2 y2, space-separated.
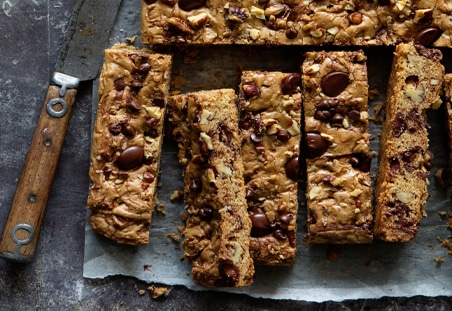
0 0 452 310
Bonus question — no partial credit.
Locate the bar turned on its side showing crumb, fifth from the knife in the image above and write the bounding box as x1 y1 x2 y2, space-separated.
374 44 444 242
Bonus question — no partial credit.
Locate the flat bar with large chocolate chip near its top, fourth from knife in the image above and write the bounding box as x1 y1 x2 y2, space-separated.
301 51 373 244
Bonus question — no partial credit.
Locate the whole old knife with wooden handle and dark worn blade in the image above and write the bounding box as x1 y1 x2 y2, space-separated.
0 0 121 263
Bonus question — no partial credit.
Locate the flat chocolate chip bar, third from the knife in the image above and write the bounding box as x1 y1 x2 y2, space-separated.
239 71 301 265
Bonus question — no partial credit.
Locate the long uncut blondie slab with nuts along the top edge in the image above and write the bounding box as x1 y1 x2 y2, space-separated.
141 0 452 47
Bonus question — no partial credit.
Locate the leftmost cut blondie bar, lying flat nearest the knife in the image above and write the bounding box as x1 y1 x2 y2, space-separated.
87 44 172 245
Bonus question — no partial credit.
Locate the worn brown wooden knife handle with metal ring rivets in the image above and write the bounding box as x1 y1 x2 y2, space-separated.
0 85 77 262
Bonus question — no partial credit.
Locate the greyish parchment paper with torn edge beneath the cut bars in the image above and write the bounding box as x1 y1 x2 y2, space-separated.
83 0 452 302
